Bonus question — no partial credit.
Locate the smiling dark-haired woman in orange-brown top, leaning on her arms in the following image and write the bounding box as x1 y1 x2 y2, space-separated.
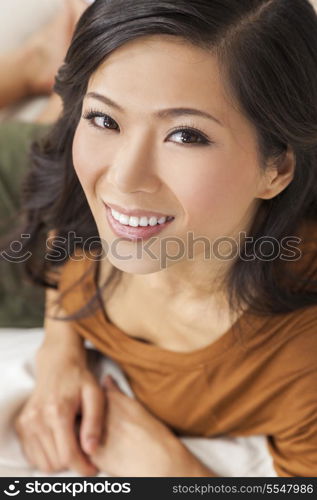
6 0 317 476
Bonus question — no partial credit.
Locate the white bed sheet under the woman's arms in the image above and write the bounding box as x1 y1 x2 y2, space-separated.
0 328 277 477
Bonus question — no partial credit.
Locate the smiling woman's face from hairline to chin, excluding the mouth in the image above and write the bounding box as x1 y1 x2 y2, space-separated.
73 35 272 274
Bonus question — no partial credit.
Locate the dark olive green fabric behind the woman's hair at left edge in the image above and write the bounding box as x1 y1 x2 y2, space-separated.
0 122 48 328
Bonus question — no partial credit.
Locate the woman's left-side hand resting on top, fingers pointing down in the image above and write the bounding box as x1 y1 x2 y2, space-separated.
15 334 105 476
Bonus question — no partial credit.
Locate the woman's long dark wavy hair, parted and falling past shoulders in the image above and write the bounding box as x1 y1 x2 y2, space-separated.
1 0 317 317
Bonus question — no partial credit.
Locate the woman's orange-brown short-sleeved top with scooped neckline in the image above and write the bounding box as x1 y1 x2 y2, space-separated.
59 219 317 477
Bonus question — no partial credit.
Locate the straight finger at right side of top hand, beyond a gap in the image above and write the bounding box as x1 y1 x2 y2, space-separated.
80 385 106 454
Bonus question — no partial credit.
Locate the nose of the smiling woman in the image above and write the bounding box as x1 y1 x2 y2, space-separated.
108 131 160 193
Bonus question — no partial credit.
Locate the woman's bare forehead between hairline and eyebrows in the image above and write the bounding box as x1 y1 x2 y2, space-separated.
88 35 225 112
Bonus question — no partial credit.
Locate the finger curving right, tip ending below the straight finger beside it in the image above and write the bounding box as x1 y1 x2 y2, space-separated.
53 416 98 476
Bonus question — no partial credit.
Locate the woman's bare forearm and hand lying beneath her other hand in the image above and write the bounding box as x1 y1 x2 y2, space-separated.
90 377 213 477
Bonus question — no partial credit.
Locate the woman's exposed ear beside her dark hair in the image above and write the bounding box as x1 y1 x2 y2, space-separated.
258 148 296 200
